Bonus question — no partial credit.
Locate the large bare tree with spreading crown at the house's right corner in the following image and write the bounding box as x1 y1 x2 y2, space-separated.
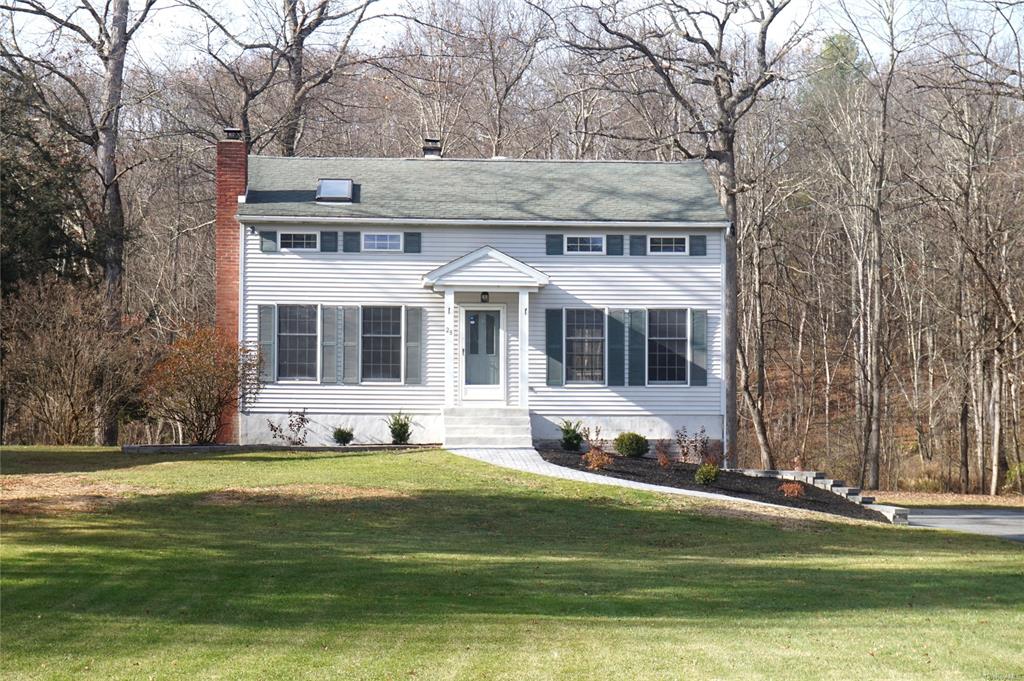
566 0 803 465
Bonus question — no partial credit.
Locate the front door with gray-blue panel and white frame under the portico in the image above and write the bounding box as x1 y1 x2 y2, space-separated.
462 306 505 403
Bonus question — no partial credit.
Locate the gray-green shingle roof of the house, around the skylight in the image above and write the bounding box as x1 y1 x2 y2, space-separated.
239 156 725 222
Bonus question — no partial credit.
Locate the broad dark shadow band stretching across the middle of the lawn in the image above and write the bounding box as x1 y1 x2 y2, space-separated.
3 483 1024 639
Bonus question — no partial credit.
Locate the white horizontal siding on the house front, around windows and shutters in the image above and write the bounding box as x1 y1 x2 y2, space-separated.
242 225 722 419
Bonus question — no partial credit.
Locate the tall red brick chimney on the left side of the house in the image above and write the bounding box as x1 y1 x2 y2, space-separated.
214 128 249 442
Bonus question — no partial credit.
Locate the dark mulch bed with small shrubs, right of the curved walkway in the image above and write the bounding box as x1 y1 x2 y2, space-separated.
540 450 888 523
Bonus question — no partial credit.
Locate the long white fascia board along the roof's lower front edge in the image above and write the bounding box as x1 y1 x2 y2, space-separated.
238 215 729 229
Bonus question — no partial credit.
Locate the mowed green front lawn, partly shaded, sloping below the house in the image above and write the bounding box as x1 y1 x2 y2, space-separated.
0 450 1024 681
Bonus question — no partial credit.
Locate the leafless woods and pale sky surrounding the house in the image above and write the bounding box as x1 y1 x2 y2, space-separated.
0 0 1024 494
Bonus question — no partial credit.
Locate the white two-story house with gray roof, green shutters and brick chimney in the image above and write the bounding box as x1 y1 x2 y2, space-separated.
216 130 728 448
